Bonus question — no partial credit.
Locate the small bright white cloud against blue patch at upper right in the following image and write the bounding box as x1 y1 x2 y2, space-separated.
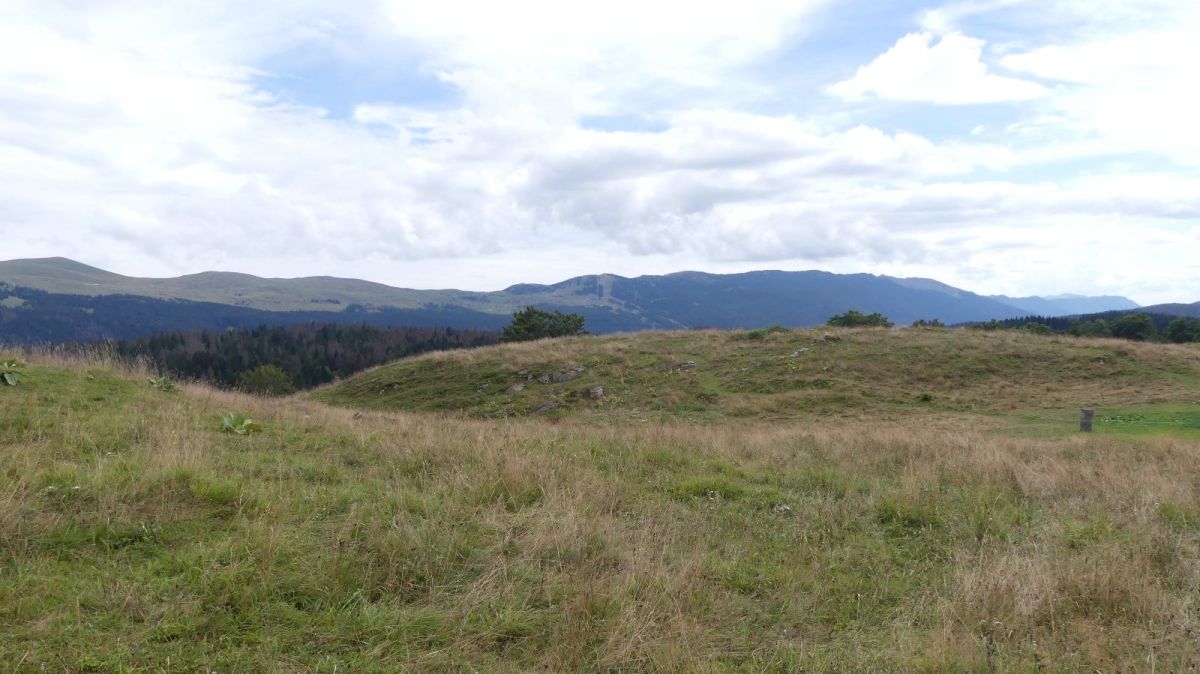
828 32 1049 106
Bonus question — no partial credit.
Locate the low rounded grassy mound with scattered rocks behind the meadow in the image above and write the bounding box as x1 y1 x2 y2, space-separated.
313 330 1200 420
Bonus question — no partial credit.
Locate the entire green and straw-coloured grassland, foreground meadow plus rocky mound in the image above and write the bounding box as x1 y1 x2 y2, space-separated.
0 331 1200 673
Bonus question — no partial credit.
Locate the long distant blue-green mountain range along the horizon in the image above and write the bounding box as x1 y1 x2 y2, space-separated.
0 258 1161 343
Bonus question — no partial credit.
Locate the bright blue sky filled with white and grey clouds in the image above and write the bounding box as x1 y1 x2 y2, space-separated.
0 0 1200 303
